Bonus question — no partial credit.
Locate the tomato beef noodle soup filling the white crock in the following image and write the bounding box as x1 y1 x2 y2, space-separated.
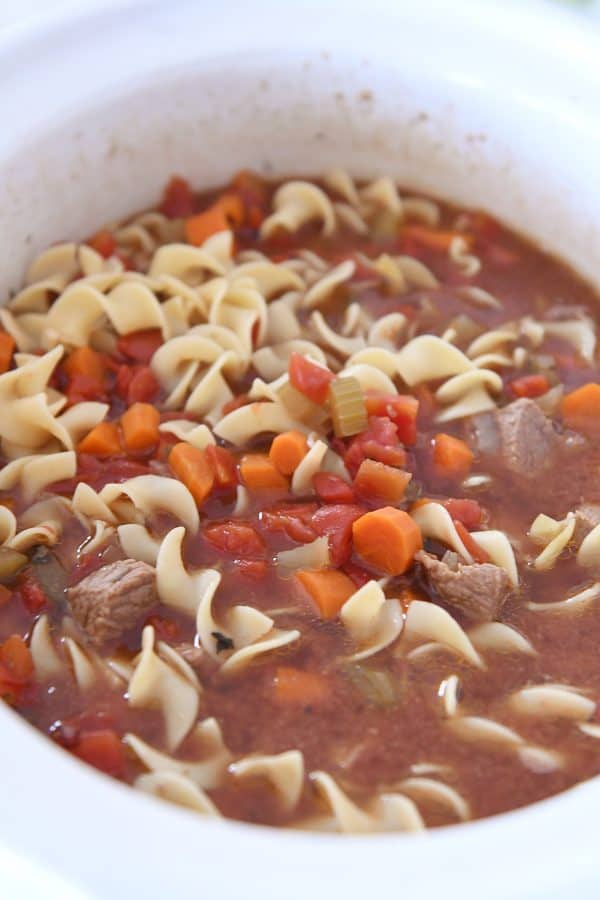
0 171 600 832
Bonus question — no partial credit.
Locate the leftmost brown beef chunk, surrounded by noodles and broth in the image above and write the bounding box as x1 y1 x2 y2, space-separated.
68 559 157 646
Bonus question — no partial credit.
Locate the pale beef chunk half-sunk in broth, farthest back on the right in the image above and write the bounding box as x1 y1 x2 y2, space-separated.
469 398 560 478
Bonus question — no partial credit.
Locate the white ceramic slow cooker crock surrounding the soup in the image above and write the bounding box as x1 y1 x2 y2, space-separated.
0 0 600 900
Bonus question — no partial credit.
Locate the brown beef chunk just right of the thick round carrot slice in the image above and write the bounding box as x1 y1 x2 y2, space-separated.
415 550 511 622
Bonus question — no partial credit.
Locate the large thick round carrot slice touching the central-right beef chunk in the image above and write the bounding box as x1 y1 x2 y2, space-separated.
352 506 423 575
